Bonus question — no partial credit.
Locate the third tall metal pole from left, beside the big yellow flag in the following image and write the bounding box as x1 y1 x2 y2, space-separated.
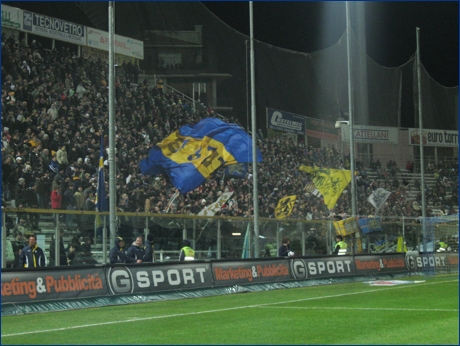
345 1 357 217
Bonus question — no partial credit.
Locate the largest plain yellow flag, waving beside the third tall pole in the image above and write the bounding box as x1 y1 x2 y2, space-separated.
299 165 351 210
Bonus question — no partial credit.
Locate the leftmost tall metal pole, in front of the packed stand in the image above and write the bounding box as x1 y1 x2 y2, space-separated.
108 1 118 244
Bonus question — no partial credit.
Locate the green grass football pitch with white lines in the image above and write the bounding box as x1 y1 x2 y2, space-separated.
1 275 459 345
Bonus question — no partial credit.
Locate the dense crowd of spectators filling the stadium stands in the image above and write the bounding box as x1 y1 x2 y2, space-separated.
2 34 458 243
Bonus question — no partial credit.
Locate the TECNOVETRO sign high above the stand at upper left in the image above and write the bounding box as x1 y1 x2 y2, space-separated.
22 11 86 45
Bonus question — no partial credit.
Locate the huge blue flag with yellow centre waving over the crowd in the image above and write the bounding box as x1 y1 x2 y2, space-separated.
139 118 262 193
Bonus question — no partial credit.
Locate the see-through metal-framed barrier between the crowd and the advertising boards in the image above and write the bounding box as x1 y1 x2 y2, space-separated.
2 208 458 268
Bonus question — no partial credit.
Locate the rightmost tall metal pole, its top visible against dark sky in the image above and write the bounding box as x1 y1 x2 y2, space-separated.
415 28 428 252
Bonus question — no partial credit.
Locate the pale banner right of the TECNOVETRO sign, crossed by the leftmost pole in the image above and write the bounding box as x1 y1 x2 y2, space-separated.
87 28 144 60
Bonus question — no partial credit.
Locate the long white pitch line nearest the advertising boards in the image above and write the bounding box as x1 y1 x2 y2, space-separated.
2 280 458 338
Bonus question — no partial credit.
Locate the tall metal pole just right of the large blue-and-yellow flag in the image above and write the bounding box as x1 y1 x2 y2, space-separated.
249 1 259 258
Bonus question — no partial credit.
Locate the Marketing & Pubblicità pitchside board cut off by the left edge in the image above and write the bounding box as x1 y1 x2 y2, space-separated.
2 267 107 303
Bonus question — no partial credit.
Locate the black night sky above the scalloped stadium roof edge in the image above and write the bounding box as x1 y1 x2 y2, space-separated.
203 1 459 86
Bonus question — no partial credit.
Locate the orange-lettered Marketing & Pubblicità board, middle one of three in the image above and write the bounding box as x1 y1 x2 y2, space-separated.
212 259 291 286
